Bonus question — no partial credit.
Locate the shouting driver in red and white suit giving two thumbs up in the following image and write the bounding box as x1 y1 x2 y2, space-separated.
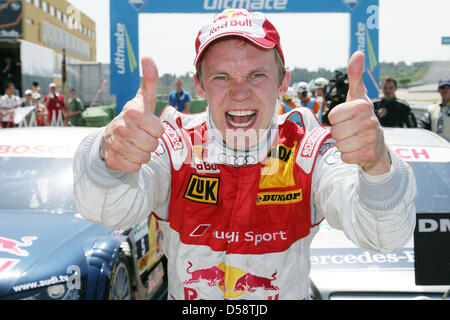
74 9 416 300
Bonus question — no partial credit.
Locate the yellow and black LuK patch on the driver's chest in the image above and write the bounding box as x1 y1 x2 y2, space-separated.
184 174 220 204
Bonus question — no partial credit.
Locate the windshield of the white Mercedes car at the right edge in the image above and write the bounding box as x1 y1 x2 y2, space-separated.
409 162 450 213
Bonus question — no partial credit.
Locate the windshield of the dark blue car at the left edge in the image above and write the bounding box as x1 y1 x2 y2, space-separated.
0 157 76 213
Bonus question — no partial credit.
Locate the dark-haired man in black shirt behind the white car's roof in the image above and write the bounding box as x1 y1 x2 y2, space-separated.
373 77 417 128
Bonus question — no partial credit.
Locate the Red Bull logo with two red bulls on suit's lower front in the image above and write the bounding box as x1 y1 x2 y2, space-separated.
183 261 279 300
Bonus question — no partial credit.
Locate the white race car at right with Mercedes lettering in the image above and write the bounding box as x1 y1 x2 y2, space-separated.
310 128 450 300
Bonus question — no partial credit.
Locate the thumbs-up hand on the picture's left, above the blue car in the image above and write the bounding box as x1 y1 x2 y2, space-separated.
100 57 164 172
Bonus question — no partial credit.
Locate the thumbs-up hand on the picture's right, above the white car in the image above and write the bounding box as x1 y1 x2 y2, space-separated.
328 52 391 175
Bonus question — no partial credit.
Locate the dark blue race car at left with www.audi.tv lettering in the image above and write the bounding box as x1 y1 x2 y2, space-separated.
0 127 167 300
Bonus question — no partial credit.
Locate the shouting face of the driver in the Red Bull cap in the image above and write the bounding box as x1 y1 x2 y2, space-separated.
195 39 290 149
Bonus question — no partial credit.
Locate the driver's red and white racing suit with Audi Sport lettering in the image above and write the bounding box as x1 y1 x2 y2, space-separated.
74 107 416 300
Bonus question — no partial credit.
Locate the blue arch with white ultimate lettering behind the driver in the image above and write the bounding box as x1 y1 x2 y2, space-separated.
110 0 379 112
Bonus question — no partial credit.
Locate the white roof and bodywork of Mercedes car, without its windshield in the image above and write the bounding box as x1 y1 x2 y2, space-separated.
310 128 450 300
